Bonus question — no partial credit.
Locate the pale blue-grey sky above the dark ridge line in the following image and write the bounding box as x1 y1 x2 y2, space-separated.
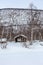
0 0 43 9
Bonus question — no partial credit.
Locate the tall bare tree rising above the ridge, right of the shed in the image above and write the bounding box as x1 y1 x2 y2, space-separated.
29 4 41 44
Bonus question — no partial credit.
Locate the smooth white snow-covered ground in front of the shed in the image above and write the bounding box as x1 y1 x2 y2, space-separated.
0 41 43 65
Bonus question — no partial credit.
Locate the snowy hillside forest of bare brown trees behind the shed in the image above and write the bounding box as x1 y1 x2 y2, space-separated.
0 5 43 42
